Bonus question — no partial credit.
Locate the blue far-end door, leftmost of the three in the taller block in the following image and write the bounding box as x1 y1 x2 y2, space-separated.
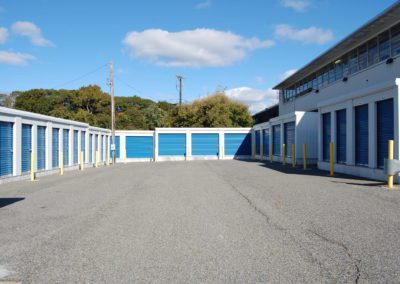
158 133 186 156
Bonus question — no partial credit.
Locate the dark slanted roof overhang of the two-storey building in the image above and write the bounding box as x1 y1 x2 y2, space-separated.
274 1 400 89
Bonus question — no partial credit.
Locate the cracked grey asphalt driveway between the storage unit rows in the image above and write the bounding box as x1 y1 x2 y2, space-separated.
0 161 400 283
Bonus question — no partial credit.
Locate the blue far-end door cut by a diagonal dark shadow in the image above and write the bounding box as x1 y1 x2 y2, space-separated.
224 133 251 156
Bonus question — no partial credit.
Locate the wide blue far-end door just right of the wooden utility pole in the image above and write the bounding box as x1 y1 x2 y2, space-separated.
125 136 153 158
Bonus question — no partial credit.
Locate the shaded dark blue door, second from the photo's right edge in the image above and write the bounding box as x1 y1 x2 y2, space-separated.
355 105 368 166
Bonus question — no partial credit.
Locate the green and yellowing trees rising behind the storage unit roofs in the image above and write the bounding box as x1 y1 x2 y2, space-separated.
0 85 253 130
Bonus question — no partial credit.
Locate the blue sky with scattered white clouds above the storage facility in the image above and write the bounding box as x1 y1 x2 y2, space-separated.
0 0 396 112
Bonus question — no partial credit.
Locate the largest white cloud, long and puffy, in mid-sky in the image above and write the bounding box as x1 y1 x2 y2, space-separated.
123 29 274 67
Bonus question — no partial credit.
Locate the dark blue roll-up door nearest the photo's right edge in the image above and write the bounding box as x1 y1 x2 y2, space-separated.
376 99 394 168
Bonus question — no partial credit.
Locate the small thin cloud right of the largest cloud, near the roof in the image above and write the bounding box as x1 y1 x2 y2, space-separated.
275 25 333 44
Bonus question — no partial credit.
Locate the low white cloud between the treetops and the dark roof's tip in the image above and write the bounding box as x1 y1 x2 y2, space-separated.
225 87 278 114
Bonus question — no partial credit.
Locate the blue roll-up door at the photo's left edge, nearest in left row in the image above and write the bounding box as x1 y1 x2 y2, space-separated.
0 121 13 176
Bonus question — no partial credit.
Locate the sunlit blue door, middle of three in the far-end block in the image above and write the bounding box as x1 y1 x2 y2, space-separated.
192 133 219 156
